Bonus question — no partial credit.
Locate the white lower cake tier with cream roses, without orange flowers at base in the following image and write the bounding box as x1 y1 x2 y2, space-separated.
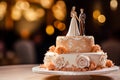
44 52 107 69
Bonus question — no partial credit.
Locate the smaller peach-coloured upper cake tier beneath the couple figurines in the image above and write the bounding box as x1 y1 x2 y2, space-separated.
56 36 94 53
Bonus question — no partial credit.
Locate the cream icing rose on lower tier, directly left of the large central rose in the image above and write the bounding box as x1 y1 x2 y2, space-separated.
53 56 65 69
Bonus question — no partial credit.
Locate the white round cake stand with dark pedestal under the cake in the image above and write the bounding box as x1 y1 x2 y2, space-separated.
32 66 119 80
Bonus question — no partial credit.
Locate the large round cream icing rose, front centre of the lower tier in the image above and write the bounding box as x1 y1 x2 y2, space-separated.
76 55 90 68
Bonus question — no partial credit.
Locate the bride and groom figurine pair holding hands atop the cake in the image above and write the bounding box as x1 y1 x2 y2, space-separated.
67 6 86 36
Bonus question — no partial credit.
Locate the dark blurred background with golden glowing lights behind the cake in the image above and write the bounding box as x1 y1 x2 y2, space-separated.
0 0 120 66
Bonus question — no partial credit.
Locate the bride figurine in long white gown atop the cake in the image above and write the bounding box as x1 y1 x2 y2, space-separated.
66 6 80 36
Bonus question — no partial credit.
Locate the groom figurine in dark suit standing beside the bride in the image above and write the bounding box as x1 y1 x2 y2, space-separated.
79 8 86 35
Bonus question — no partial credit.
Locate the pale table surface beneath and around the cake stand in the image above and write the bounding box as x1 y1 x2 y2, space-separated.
0 64 120 80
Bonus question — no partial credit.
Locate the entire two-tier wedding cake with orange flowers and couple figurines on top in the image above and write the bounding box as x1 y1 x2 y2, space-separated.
40 7 114 71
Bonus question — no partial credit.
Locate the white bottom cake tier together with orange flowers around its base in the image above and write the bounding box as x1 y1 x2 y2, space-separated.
40 51 114 71
